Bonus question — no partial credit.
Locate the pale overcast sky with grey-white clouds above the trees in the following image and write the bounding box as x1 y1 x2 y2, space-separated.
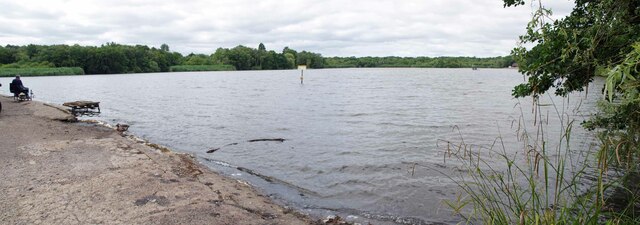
0 0 573 57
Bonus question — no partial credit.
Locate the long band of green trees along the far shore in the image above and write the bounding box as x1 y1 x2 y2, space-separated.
0 43 514 76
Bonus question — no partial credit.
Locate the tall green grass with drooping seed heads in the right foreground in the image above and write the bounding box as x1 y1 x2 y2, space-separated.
444 95 640 224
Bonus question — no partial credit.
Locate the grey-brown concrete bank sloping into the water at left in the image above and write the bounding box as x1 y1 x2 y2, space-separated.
0 95 322 224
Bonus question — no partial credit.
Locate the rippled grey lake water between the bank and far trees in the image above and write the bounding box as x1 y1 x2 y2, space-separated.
0 69 602 224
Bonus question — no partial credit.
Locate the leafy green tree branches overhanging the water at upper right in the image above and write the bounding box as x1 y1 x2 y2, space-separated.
504 0 640 97
